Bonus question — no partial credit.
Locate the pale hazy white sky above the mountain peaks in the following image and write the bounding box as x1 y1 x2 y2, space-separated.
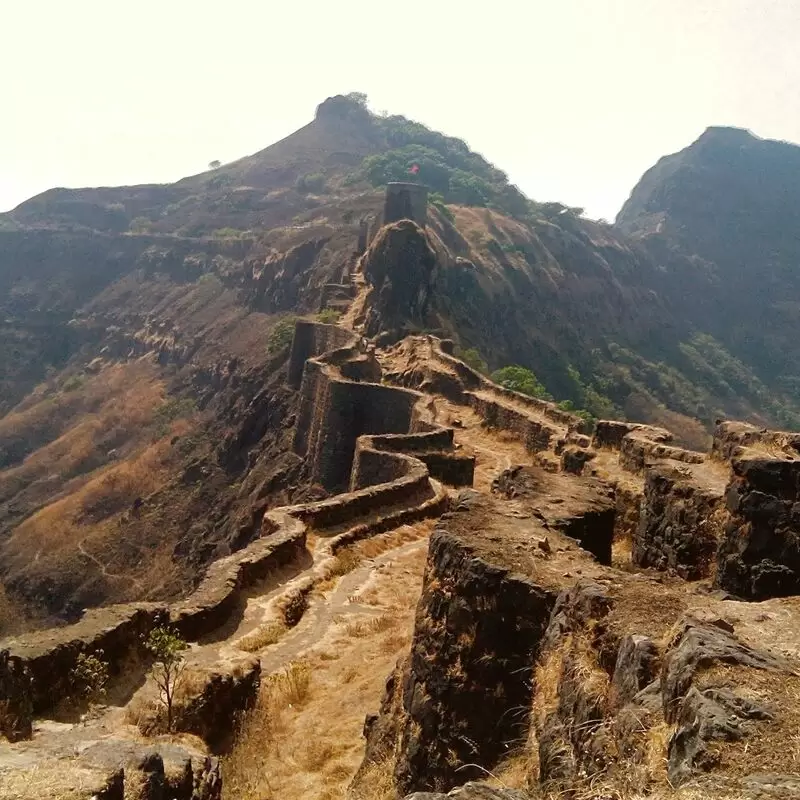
0 0 800 218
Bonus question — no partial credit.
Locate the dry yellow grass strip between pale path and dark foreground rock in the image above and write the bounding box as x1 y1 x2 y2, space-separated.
223 548 425 800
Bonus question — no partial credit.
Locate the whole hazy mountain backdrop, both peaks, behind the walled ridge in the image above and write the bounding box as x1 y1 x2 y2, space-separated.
0 95 800 630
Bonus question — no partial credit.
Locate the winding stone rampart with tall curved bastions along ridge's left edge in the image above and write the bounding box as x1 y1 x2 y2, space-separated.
0 322 462 738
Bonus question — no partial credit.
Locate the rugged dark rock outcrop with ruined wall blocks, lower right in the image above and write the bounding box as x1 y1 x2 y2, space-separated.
352 406 800 798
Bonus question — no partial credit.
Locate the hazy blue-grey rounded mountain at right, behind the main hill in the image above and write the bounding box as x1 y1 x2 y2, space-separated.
617 128 800 410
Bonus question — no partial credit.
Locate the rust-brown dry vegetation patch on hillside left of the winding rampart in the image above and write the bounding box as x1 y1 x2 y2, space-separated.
0 360 200 608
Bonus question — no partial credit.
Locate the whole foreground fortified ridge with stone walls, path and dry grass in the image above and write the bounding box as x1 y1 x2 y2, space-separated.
0 304 800 800
